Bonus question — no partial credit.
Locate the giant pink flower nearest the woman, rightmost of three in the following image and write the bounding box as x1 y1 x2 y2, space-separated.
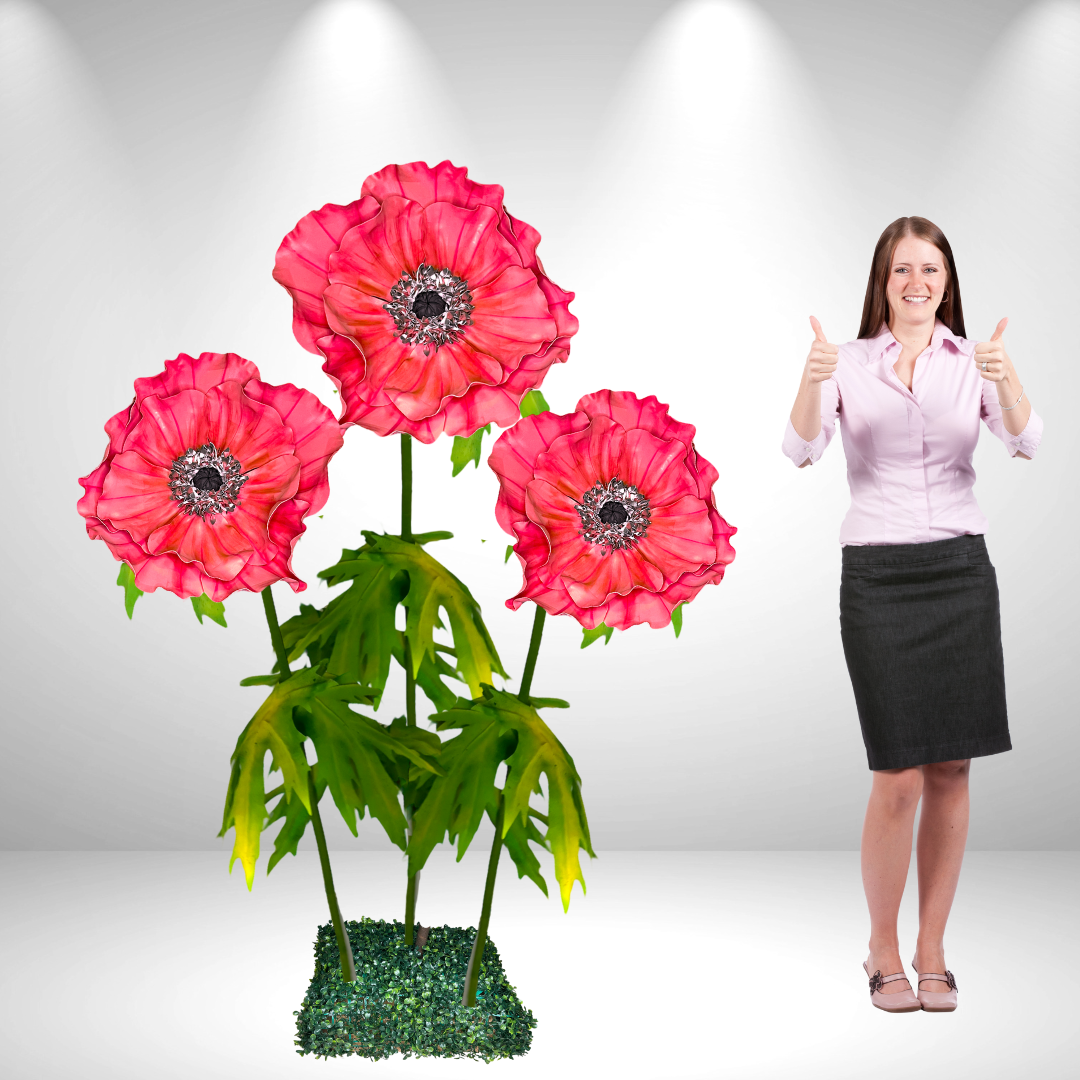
488 390 735 630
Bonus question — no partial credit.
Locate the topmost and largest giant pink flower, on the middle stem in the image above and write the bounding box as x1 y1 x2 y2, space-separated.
273 161 578 443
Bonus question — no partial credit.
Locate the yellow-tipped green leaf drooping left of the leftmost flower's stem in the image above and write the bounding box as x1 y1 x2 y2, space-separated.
217 667 319 890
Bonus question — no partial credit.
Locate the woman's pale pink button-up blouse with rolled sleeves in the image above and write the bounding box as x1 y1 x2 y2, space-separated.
783 322 1042 544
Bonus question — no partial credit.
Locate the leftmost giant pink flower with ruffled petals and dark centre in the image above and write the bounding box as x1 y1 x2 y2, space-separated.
79 352 342 600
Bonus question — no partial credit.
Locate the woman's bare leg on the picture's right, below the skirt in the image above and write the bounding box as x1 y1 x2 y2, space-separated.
915 760 971 994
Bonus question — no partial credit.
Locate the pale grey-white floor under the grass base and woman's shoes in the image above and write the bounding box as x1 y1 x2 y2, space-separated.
0 851 1080 1080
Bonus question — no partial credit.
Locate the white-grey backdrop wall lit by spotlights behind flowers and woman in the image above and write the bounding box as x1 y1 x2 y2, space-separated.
0 0 1080 859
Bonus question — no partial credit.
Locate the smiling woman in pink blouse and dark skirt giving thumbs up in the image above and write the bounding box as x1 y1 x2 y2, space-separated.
783 217 1042 1012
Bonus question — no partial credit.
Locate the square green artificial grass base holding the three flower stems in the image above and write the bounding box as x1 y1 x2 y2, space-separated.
293 918 537 1062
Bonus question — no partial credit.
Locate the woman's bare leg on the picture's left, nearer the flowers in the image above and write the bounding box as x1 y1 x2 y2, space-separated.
862 768 922 994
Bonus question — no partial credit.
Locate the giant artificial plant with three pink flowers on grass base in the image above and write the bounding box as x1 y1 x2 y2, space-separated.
79 161 735 1062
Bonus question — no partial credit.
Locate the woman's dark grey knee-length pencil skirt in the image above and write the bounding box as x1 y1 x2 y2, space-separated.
840 536 1012 770
